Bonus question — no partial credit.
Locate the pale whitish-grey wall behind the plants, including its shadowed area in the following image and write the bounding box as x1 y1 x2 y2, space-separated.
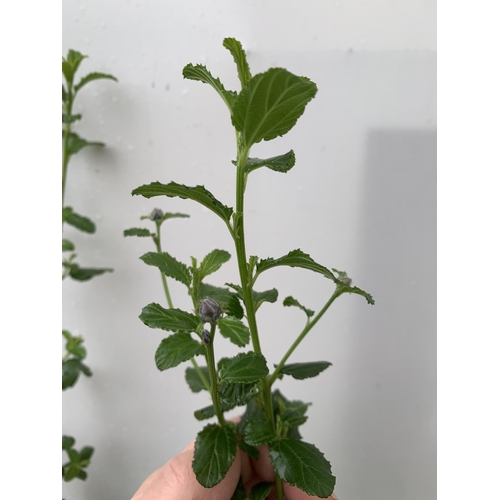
63 0 436 500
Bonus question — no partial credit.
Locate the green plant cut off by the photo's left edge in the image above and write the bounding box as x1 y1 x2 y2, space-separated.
62 50 117 481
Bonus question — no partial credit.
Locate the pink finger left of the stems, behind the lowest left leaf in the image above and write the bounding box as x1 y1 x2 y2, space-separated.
132 445 241 500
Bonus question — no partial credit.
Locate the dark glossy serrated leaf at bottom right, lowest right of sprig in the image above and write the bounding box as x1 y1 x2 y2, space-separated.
269 438 335 498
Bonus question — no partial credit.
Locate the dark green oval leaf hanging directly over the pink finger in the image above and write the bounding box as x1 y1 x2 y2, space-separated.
193 424 236 488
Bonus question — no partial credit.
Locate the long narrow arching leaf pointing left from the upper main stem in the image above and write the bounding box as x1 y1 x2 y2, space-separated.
132 182 233 224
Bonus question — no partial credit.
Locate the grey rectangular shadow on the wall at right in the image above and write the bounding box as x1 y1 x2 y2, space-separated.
339 130 437 500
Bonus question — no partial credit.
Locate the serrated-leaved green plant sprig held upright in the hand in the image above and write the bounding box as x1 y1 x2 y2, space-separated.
132 38 374 499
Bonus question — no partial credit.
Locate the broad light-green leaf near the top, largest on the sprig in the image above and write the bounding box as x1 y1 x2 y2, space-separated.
232 68 317 148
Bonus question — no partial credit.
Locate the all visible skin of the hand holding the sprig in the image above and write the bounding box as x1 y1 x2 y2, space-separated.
132 441 338 500
